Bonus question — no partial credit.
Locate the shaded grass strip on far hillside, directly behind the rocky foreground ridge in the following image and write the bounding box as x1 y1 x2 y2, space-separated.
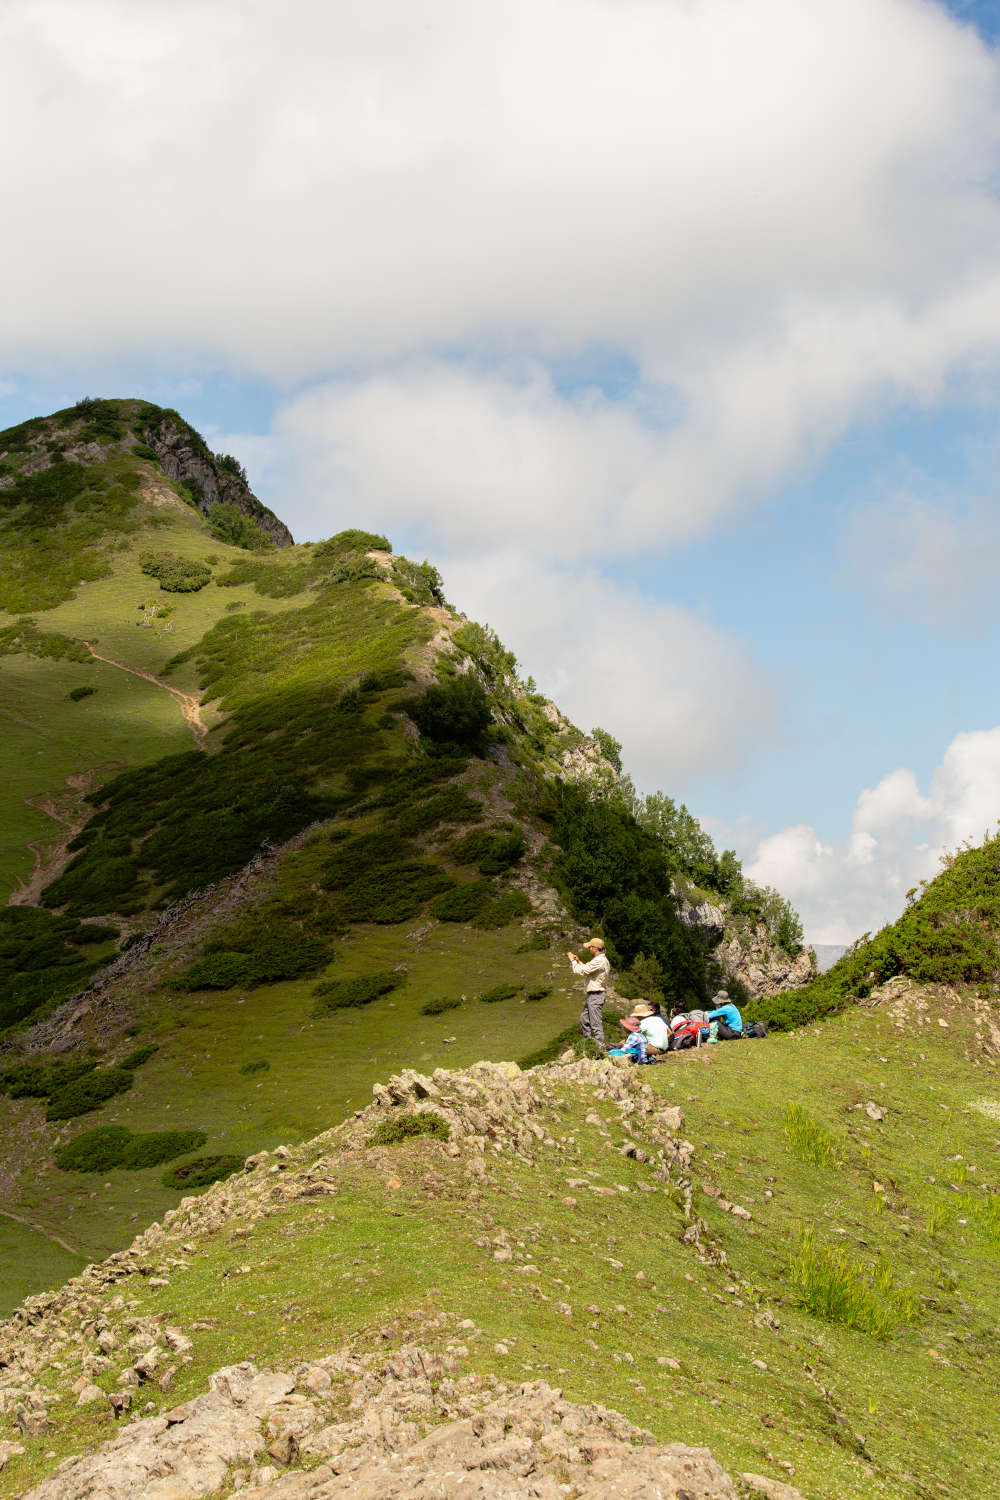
7 923 576 1290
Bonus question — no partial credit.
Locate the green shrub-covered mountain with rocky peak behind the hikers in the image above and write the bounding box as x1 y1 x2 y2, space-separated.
0 402 749 1305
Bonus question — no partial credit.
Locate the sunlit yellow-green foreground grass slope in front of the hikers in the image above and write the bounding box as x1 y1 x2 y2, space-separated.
0 999 1000 1500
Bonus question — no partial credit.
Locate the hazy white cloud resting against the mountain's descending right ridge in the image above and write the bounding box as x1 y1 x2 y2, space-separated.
444 549 774 789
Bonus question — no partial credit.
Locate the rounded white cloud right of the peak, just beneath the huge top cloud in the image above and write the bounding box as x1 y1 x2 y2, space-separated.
276 363 743 557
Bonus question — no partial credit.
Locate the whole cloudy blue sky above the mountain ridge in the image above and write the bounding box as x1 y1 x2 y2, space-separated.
0 0 1000 944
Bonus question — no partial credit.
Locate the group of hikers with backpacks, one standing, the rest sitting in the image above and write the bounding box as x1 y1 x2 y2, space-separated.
567 938 768 1064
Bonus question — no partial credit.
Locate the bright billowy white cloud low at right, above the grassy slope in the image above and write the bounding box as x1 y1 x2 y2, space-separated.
747 726 1000 944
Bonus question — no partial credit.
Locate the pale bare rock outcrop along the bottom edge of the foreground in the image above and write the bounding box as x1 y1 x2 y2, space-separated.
25 1350 801 1500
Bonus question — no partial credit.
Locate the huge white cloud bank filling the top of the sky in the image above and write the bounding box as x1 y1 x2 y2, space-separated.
0 0 1000 558
